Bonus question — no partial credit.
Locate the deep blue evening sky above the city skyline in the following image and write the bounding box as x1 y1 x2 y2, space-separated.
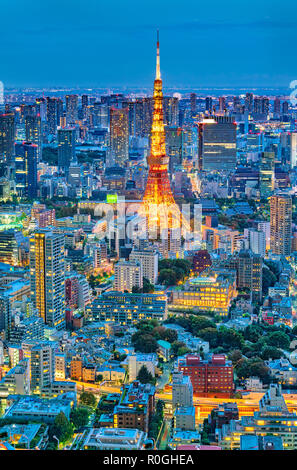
0 0 297 87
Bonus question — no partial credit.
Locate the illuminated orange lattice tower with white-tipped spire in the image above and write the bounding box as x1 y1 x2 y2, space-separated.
139 33 181 232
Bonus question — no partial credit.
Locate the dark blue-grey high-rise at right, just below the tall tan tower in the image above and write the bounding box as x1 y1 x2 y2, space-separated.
237 250 262 301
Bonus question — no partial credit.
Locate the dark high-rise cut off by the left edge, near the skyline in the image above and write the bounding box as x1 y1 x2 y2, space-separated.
0 113 15 165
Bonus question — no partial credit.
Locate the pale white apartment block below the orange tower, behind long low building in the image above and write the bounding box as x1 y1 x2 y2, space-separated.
114 259 143 292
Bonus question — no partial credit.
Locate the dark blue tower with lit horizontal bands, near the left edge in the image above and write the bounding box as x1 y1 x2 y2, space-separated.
14 142 38 198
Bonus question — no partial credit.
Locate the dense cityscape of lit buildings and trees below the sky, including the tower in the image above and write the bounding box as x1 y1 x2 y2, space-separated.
0 6 297 451
